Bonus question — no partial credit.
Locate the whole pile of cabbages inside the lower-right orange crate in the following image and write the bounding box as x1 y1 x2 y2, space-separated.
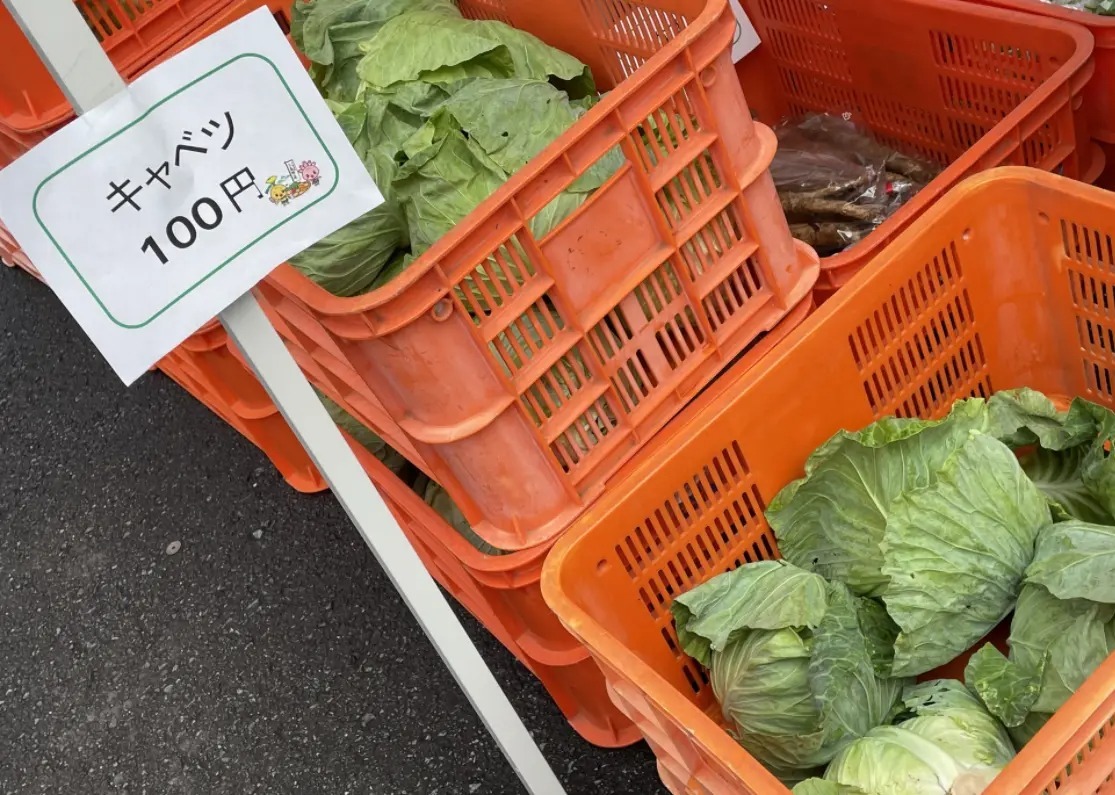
672 389 1115 795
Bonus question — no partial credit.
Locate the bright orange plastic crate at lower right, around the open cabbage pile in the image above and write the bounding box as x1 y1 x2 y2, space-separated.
542 168 1115 795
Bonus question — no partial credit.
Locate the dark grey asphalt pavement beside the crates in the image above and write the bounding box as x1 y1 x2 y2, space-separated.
0 268 662 795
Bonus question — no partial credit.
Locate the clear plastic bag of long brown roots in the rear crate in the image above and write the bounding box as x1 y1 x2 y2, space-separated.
770 114 940 256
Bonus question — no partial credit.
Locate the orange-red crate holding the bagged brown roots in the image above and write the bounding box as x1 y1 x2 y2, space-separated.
737 0 1097 294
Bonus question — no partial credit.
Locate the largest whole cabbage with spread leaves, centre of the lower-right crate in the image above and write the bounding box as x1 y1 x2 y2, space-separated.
767 399 1051 676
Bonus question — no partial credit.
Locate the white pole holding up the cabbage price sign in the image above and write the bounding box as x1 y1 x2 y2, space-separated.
3 0 565 795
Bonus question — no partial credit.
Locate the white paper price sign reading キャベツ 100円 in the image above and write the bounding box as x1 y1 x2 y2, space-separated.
0 9 382 384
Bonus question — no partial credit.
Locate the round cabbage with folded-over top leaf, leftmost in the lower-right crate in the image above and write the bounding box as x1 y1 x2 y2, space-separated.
672 561 905 783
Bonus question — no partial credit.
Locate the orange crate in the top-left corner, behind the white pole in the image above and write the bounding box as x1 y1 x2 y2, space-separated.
0 0 291 134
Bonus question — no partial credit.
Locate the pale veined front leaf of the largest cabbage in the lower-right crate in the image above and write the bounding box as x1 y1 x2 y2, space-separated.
882 433 1050 676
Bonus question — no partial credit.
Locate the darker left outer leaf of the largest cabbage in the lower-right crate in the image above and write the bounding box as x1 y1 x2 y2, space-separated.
766 399 987 595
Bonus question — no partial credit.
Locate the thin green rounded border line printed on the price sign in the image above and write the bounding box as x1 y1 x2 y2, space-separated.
31 52 340 329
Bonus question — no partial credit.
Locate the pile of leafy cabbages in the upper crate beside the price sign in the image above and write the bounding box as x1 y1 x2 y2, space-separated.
291 0 622 297
